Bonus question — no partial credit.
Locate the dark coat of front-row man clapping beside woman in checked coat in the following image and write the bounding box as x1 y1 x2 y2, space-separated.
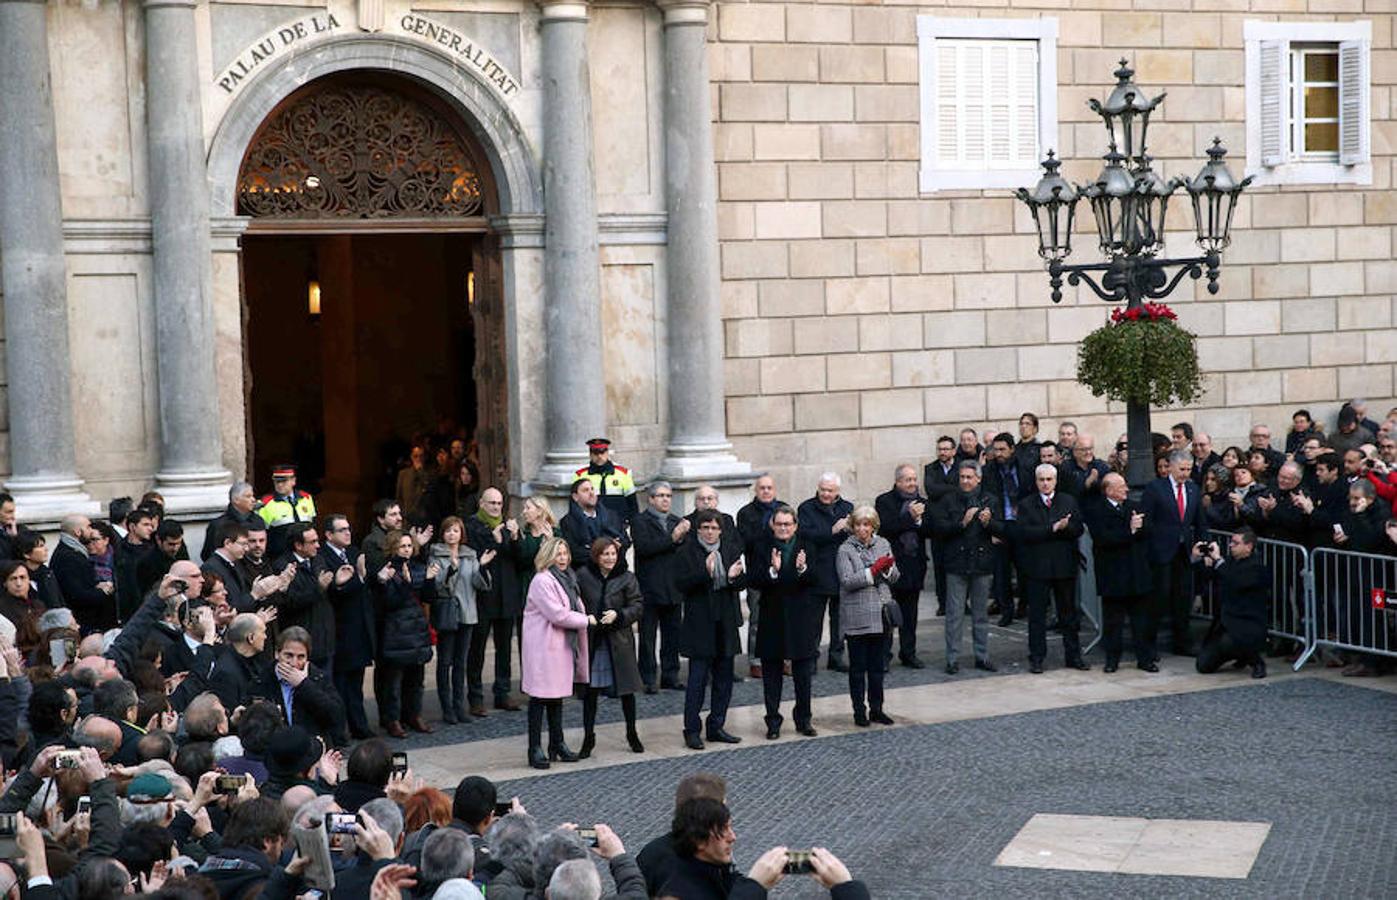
747 531 824 660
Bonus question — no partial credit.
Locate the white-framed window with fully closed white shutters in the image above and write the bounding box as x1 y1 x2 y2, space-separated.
916 15 1058 193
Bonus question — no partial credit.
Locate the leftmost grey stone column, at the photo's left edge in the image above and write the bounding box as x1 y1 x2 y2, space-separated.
0 0 98 524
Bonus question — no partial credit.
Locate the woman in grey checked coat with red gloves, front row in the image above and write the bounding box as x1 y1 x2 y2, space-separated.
834 506 898 728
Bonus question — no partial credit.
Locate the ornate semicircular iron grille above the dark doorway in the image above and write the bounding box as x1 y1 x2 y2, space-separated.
237 87 483 219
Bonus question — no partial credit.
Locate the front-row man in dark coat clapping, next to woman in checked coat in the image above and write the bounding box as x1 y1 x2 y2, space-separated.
747 503 824 741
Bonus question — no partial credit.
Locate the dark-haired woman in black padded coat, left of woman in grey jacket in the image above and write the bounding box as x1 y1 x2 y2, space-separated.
370 528 437 738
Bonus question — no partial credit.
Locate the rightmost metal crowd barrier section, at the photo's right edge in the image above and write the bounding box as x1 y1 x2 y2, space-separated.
1295 548 1397 668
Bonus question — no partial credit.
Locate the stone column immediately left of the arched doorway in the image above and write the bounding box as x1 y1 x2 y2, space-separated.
145 0 232 511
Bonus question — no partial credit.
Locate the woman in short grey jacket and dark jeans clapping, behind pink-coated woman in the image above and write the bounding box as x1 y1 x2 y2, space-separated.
427 516 495 725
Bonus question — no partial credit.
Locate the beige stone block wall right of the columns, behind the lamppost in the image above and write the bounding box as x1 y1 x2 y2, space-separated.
710 0 1397 496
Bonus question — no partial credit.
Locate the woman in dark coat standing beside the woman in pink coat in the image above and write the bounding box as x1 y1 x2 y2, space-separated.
577 538 645 759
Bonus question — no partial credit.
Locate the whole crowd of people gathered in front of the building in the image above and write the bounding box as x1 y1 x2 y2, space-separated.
0 401 1397 900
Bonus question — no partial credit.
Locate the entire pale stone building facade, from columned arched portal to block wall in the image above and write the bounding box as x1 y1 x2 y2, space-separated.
0 0 1397 528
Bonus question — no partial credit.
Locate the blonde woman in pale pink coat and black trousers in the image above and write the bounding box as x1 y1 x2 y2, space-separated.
521 537 597 769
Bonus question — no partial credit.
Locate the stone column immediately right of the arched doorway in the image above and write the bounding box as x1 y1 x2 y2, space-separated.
536 0 606 485
